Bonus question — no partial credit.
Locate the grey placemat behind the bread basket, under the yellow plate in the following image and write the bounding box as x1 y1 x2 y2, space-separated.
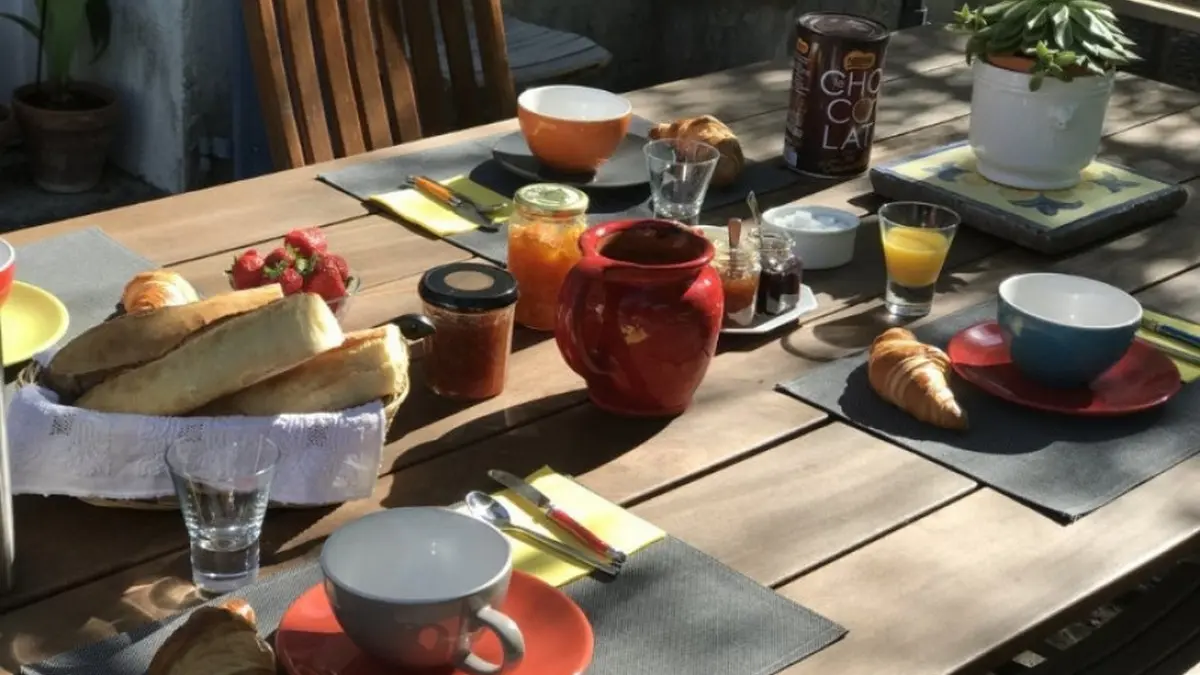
17 227 158 345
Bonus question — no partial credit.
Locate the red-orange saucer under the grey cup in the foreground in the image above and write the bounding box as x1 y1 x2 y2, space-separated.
275 572 593 675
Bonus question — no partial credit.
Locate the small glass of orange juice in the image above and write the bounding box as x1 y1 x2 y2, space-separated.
880 202 961 318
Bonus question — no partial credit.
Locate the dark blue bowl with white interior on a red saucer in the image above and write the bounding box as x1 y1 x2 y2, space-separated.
996 273 1141 388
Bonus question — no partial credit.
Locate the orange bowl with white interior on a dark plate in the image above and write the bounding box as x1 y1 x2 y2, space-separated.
517 84 634 173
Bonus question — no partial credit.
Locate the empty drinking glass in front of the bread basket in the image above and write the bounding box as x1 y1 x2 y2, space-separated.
167 438 280 593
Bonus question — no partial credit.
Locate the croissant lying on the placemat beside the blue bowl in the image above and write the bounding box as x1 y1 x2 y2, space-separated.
866 328 967 430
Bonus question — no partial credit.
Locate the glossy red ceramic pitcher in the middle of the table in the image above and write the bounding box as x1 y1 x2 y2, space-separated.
554 220 725 416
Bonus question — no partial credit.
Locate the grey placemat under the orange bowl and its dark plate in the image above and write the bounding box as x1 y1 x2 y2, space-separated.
317 117 803 265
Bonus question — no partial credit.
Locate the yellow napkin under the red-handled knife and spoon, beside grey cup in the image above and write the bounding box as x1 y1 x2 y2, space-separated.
463 466 666 586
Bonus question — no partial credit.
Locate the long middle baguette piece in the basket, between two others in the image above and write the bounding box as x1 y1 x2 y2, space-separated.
76 293 344 416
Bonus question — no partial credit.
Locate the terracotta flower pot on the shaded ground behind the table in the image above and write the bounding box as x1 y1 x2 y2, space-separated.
13 82 118 192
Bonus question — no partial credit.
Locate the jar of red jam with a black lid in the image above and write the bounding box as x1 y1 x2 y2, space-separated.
418 263 517 401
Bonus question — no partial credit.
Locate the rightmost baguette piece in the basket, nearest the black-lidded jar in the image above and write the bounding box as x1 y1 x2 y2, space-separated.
199 324 408 416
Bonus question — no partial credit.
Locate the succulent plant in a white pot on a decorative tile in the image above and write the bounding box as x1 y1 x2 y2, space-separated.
954 0 1138 190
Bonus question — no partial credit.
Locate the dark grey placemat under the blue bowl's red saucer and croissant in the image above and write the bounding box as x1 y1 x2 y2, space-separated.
779 300 1200 522
